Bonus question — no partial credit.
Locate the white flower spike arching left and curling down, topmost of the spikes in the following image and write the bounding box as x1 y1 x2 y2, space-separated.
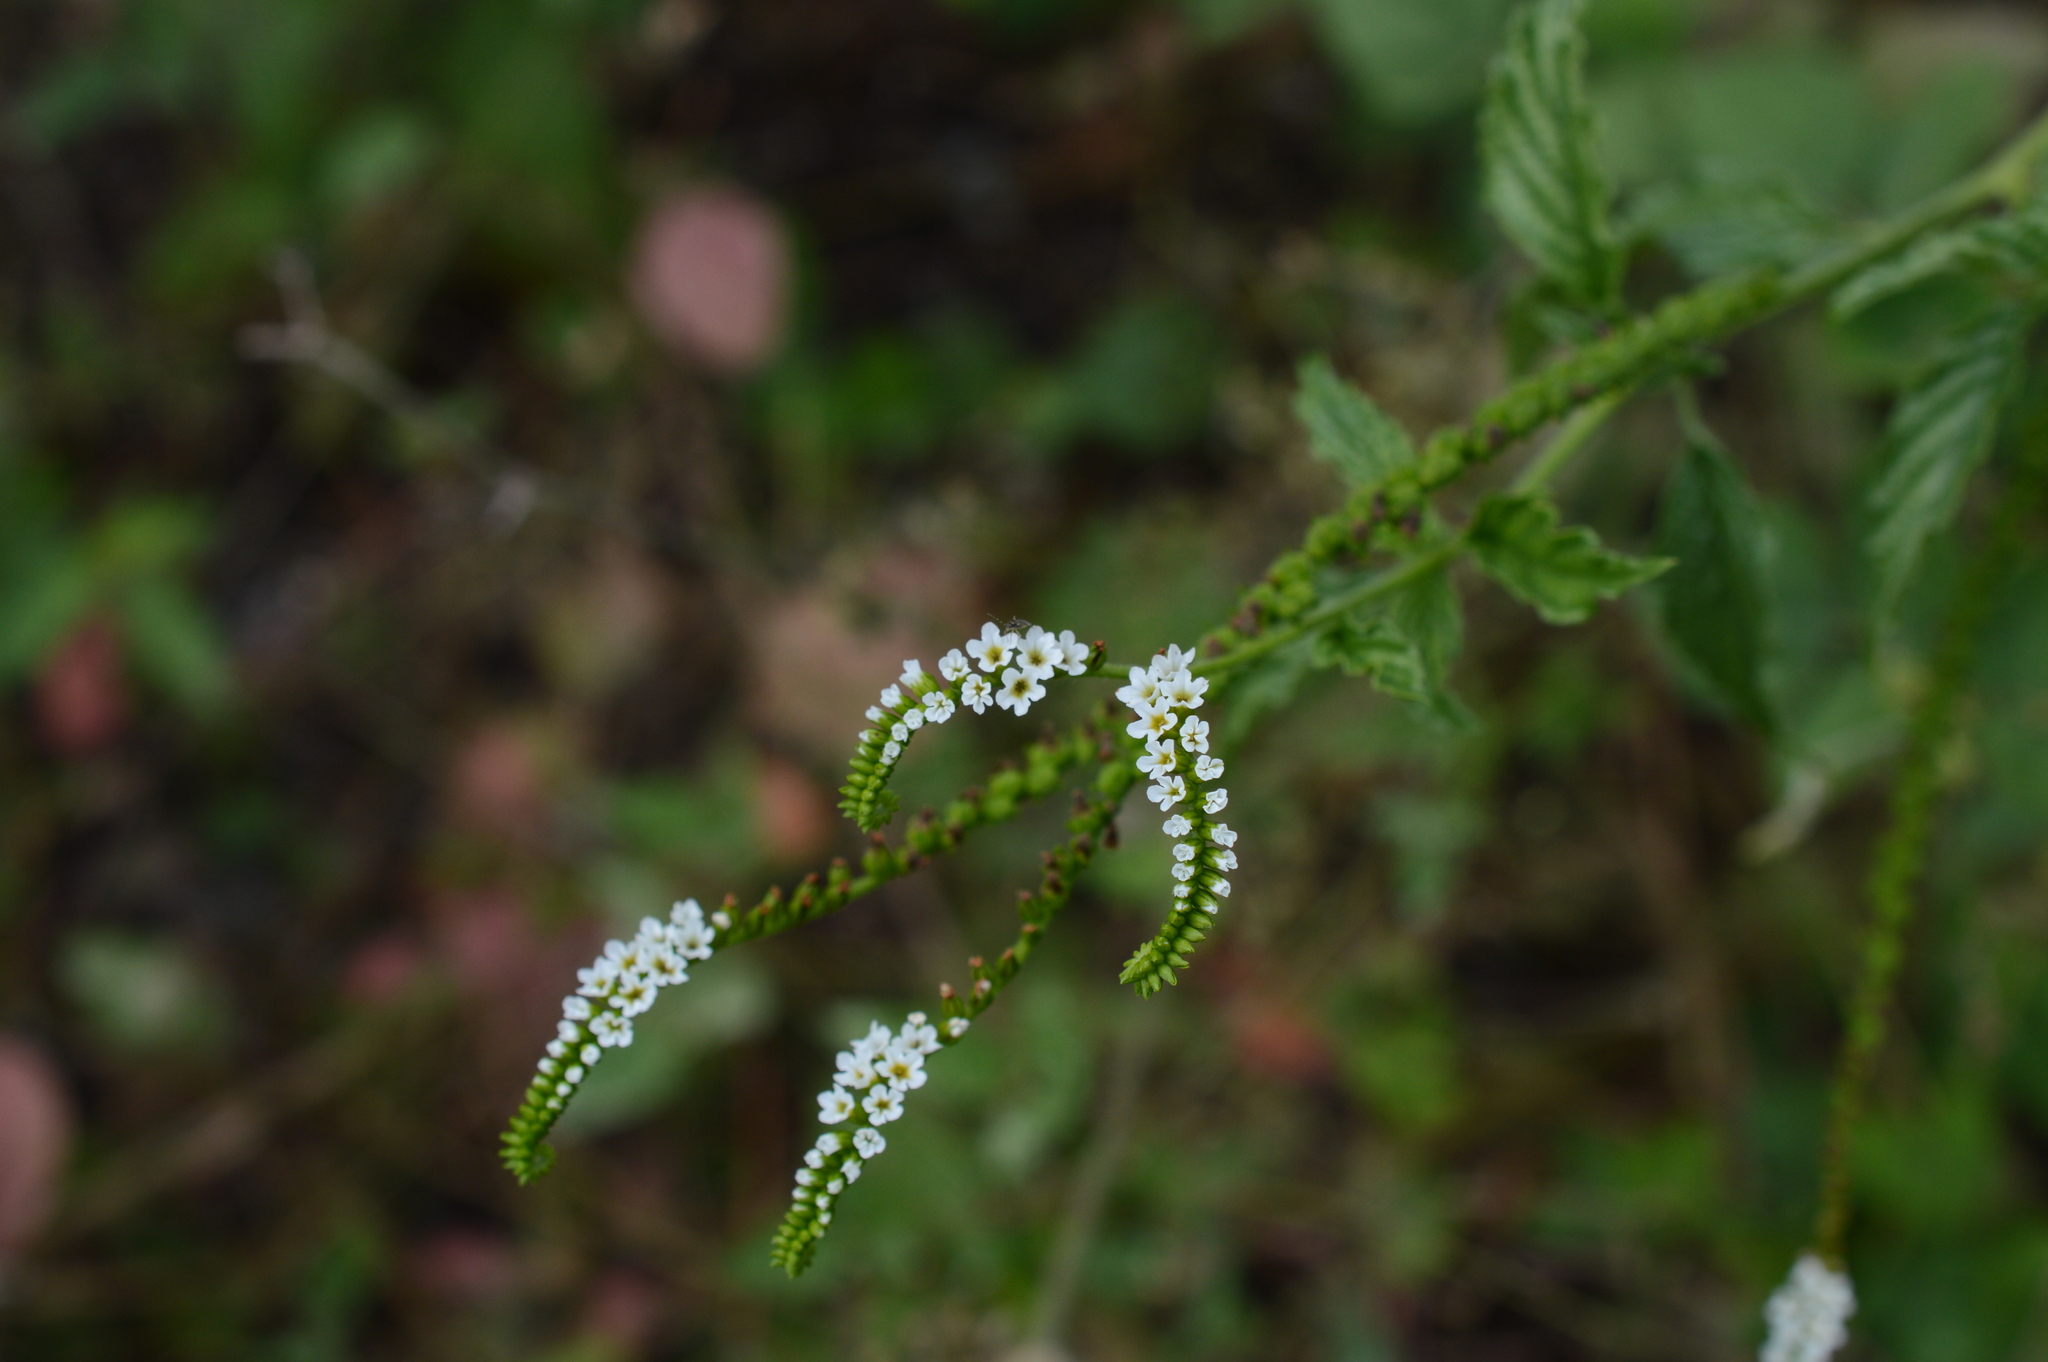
840 625 1092 832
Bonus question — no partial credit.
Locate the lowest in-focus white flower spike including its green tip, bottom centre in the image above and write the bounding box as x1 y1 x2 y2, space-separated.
770 1012 967 1276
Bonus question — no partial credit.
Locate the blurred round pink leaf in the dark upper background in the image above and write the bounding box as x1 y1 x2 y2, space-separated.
631 188 788 373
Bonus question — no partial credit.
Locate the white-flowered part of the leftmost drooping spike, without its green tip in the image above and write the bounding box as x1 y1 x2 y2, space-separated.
539 899 731 1112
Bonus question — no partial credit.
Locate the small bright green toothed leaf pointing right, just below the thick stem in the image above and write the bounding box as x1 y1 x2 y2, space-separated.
1466 496 1671 625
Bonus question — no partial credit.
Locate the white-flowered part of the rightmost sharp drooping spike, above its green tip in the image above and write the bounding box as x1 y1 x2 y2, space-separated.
1116 645 1237 911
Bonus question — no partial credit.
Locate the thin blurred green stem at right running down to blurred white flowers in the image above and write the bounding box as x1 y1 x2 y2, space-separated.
1812 459 2042 1268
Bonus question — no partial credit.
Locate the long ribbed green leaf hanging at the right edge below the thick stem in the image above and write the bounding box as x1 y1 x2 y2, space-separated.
1864 305 2032 612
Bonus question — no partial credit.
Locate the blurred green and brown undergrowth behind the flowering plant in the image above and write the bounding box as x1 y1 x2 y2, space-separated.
12 0 2048 1362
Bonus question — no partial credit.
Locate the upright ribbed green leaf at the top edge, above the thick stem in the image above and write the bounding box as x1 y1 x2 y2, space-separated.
1479 0 1622 311
